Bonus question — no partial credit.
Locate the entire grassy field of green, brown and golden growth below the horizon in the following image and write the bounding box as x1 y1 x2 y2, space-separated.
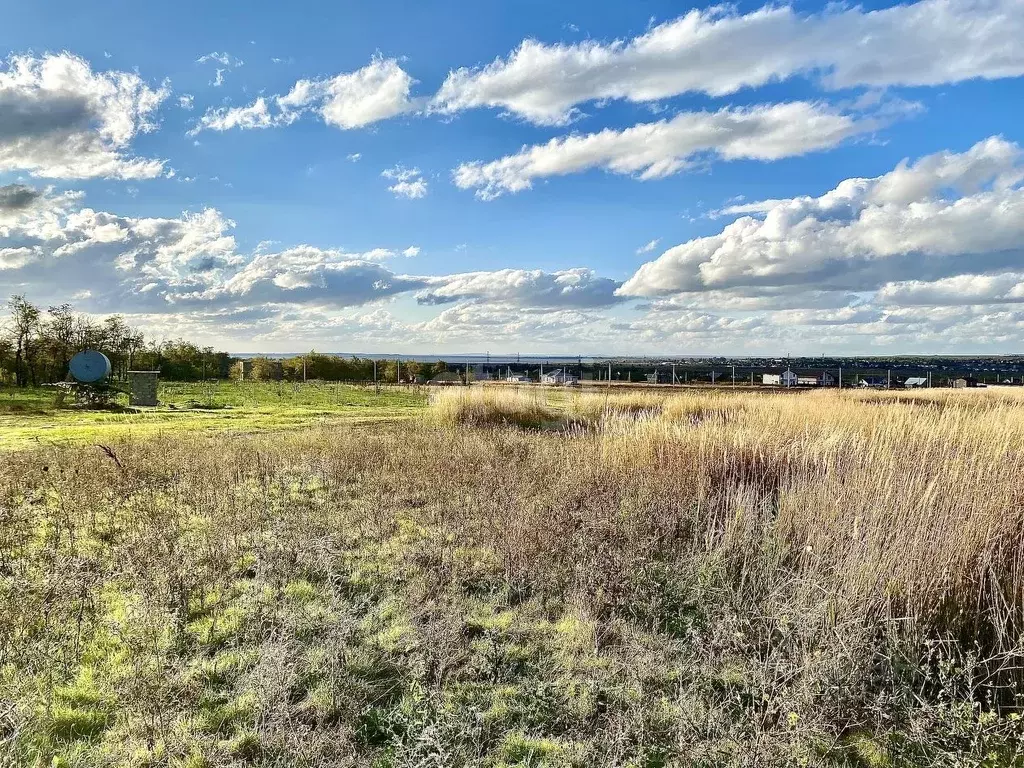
0 385 1024 768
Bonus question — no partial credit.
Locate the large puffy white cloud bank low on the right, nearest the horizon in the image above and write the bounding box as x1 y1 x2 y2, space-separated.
620 137 1024 297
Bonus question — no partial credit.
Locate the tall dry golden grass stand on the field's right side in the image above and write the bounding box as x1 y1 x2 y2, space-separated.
433 388 1024 650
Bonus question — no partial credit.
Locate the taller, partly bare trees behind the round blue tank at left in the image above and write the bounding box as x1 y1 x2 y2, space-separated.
0 296 232 387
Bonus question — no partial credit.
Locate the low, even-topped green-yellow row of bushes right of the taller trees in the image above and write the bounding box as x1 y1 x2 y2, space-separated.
231 352 447 383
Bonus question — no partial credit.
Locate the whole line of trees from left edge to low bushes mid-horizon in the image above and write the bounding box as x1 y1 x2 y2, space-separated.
0 295 447 387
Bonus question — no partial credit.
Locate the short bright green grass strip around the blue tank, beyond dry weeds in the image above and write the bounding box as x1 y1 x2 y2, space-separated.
0 382 425 451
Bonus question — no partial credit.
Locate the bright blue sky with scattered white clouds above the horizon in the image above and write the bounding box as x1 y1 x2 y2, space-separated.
0 0 1024 355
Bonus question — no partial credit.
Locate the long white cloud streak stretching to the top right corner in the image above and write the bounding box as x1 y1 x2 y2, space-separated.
433 0 1024 125
